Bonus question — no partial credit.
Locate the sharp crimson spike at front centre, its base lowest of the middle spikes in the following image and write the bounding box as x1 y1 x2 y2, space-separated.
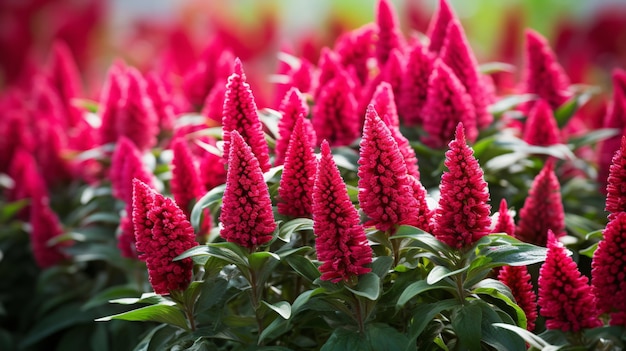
313 141 372 283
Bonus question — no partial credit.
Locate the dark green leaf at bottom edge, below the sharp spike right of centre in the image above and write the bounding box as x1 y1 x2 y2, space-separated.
451 303 482 351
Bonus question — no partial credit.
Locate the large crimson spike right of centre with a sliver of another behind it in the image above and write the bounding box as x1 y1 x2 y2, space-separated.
358 105 417 232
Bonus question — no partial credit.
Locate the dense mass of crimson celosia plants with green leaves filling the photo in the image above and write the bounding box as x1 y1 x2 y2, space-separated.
0 0 626 351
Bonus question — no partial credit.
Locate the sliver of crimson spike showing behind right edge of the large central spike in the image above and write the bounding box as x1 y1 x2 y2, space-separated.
371 82 420 180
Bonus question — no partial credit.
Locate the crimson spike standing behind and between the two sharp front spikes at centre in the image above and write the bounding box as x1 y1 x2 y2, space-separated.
278 115 317 217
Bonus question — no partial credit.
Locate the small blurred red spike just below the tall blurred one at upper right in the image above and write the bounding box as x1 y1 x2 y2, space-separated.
524 100 561 146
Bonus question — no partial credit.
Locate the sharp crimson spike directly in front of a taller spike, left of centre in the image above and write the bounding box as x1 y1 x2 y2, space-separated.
220 131 276 251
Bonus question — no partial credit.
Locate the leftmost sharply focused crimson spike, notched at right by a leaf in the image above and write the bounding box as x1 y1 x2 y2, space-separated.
133 181 198 295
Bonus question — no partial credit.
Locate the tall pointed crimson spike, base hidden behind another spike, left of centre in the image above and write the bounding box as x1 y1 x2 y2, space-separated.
222 59 271 172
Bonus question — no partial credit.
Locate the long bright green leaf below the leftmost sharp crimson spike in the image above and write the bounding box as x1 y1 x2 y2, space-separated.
95 304 189 330
